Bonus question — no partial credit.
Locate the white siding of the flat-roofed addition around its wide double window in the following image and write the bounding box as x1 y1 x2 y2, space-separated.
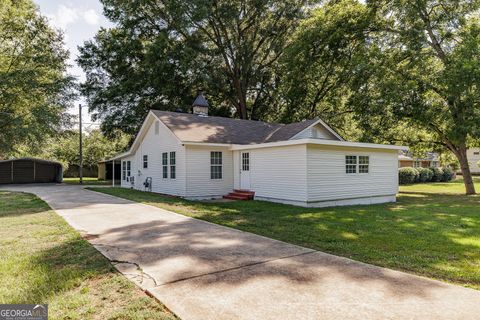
307 145 398 202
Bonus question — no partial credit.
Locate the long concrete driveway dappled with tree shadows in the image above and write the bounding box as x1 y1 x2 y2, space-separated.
3 185 480 320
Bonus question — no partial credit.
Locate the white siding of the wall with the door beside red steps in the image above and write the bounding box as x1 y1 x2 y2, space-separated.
234 145 307 201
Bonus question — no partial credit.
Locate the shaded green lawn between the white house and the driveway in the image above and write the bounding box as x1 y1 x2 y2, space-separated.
93 180 480 290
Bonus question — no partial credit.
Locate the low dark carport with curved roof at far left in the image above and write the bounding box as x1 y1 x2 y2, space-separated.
0 158 63 184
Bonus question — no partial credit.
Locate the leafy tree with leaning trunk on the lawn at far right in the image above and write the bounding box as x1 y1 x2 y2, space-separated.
351 0 480 194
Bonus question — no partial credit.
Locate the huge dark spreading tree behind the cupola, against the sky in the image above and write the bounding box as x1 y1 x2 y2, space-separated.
78 0 307 136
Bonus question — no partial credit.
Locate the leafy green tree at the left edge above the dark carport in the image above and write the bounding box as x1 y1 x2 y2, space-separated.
0 0 73 158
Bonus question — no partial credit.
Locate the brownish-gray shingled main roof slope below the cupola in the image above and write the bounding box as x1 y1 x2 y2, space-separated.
152 110 317 144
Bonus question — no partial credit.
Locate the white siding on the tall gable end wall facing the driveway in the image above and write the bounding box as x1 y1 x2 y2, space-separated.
122 117 186 196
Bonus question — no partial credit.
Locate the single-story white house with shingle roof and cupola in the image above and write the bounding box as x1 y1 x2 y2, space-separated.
114 95 405 207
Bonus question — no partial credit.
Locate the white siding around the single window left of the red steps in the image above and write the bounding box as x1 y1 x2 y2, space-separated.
186 146 233 198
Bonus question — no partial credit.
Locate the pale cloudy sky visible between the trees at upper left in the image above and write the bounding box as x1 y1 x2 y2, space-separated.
34 0 112 128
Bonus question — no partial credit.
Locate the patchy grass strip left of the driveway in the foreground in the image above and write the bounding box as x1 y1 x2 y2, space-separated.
0 191 175 319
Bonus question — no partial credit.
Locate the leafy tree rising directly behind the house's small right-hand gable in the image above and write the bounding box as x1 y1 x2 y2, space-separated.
281 0 374 139
